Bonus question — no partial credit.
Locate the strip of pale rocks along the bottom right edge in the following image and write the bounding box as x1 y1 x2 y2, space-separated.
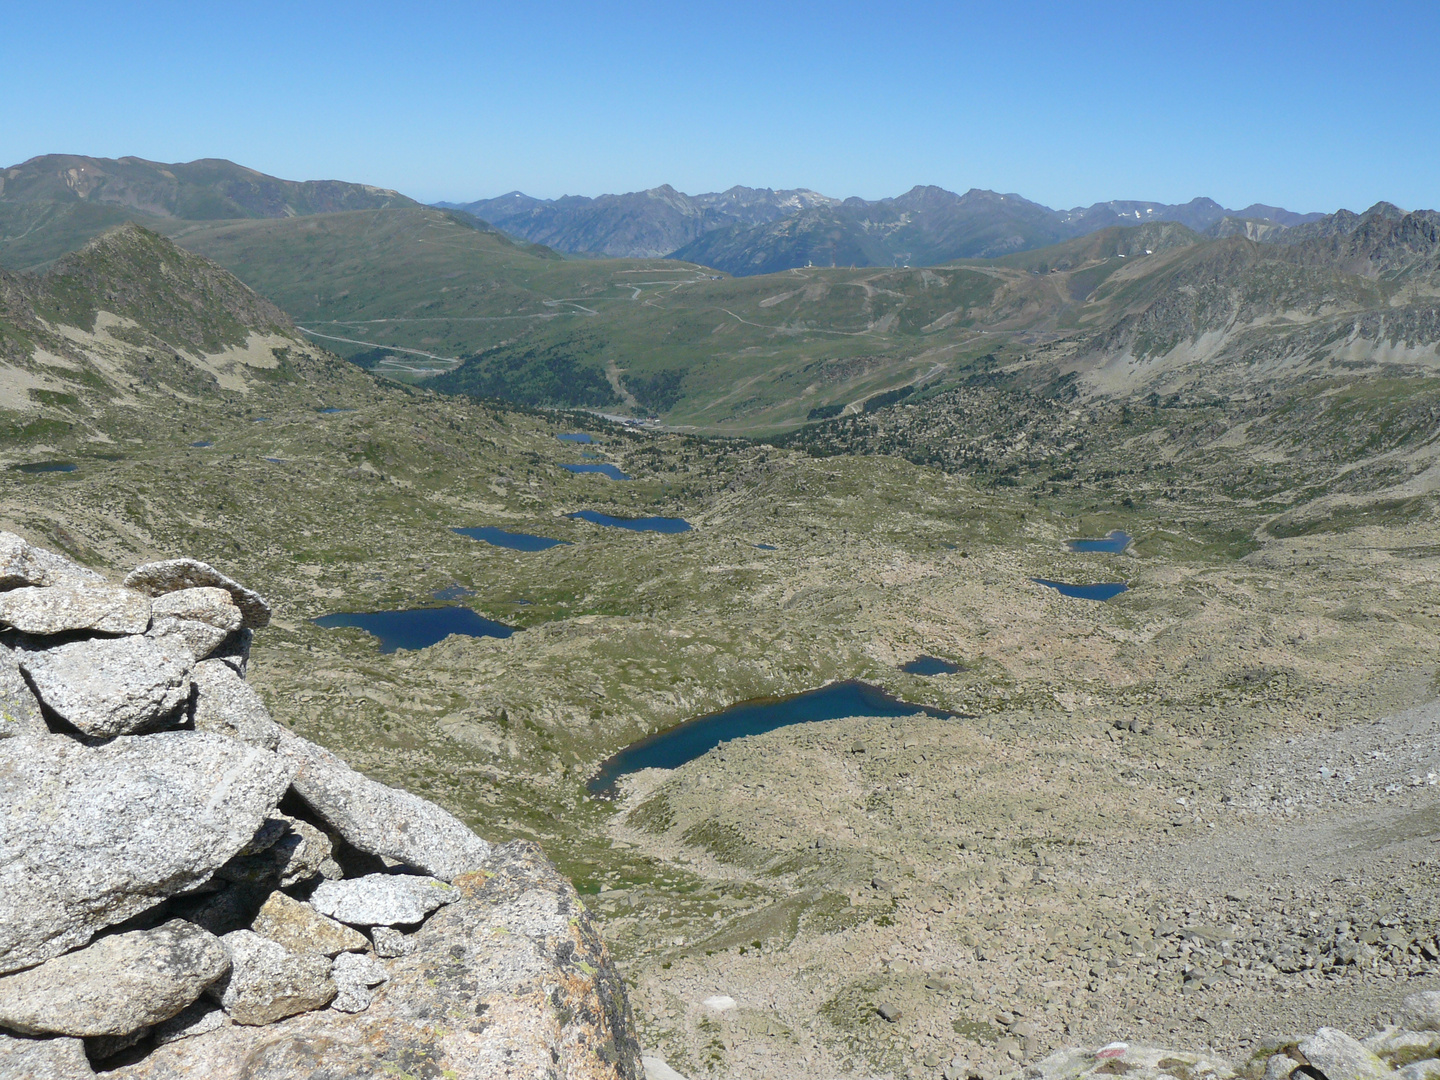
1019 991 1440 1080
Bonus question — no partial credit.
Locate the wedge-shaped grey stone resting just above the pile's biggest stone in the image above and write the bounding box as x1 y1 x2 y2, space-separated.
19 638 190 739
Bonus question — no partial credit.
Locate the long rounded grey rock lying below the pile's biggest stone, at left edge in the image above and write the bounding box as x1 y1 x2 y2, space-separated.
0 919 230 1037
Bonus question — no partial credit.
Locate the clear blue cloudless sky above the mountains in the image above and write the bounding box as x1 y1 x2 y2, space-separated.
0 0 1440 210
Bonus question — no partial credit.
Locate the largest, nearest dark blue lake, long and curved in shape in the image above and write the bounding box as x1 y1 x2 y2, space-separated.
586 680 955 798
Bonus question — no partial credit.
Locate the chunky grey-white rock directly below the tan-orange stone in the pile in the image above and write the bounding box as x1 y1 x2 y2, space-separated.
212 930 336 1024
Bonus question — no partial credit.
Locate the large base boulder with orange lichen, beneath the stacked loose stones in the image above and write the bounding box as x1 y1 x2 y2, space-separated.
108 842 642 1080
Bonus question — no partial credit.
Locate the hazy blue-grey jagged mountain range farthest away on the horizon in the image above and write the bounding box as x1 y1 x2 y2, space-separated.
438 184 1322 275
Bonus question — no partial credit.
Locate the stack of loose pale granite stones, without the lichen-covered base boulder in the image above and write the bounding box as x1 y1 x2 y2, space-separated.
0 533 491 1080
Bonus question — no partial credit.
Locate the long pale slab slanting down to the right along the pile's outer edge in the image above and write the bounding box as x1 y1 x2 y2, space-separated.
279 732 490 881
